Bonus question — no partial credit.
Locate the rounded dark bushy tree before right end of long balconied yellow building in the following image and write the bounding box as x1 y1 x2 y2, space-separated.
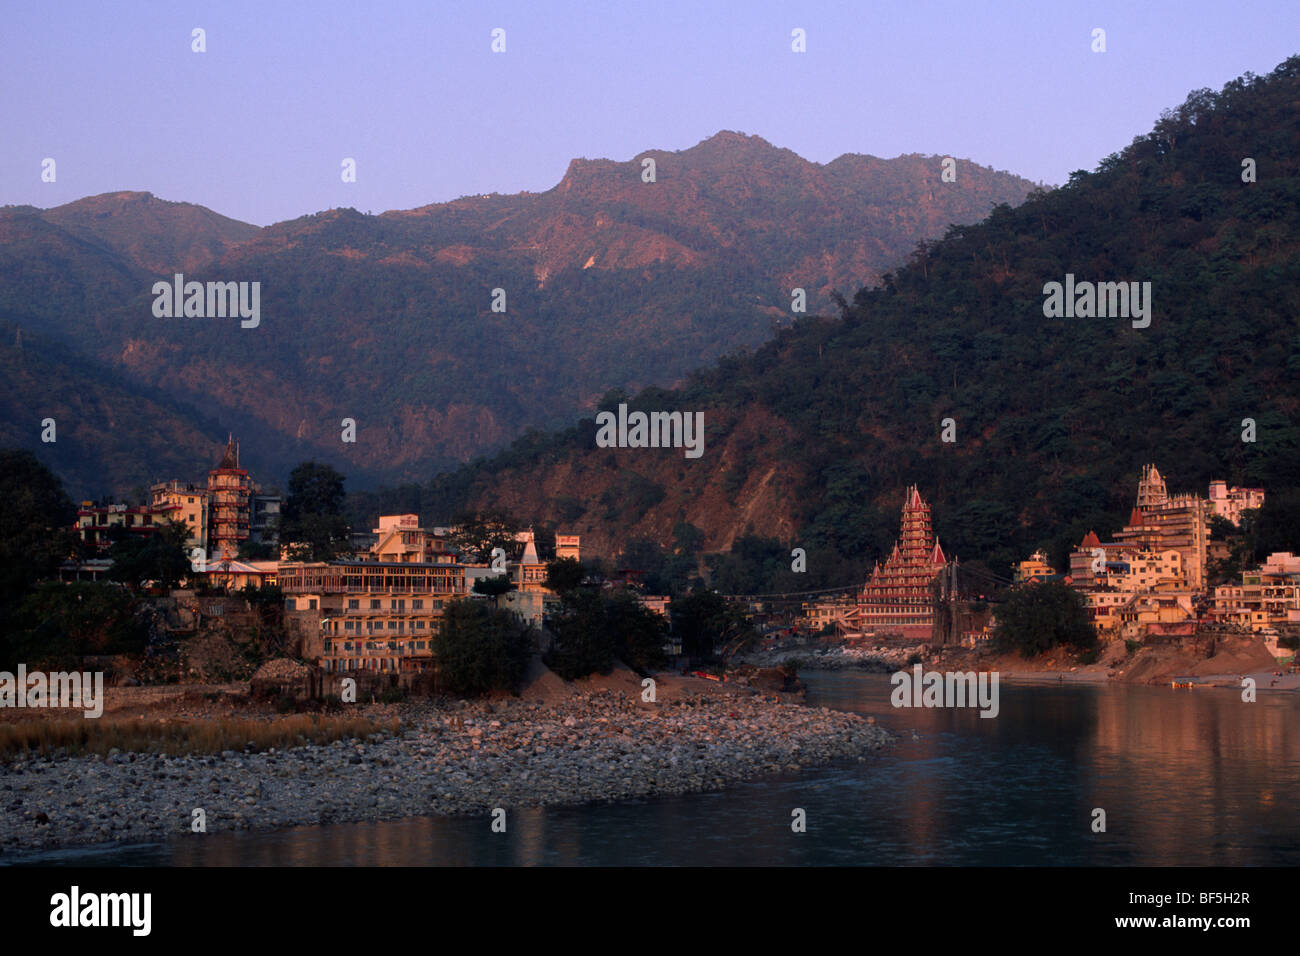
433 600 533 696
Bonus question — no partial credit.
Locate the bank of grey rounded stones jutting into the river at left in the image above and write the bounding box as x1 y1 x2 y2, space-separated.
0 691 891 858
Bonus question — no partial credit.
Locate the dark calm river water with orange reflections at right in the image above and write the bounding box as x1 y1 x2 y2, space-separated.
12 672 1300 866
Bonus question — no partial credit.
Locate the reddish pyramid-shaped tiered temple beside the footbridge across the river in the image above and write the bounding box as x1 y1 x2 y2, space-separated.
858 485 948 641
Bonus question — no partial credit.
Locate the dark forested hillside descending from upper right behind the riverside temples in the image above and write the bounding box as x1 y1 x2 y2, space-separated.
392 57 1300 581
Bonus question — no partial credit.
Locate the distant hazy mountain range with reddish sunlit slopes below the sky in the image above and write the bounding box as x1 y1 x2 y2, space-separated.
0 131 1034 497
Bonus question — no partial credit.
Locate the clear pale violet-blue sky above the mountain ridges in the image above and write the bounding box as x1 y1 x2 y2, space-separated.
0 0 1300 225
